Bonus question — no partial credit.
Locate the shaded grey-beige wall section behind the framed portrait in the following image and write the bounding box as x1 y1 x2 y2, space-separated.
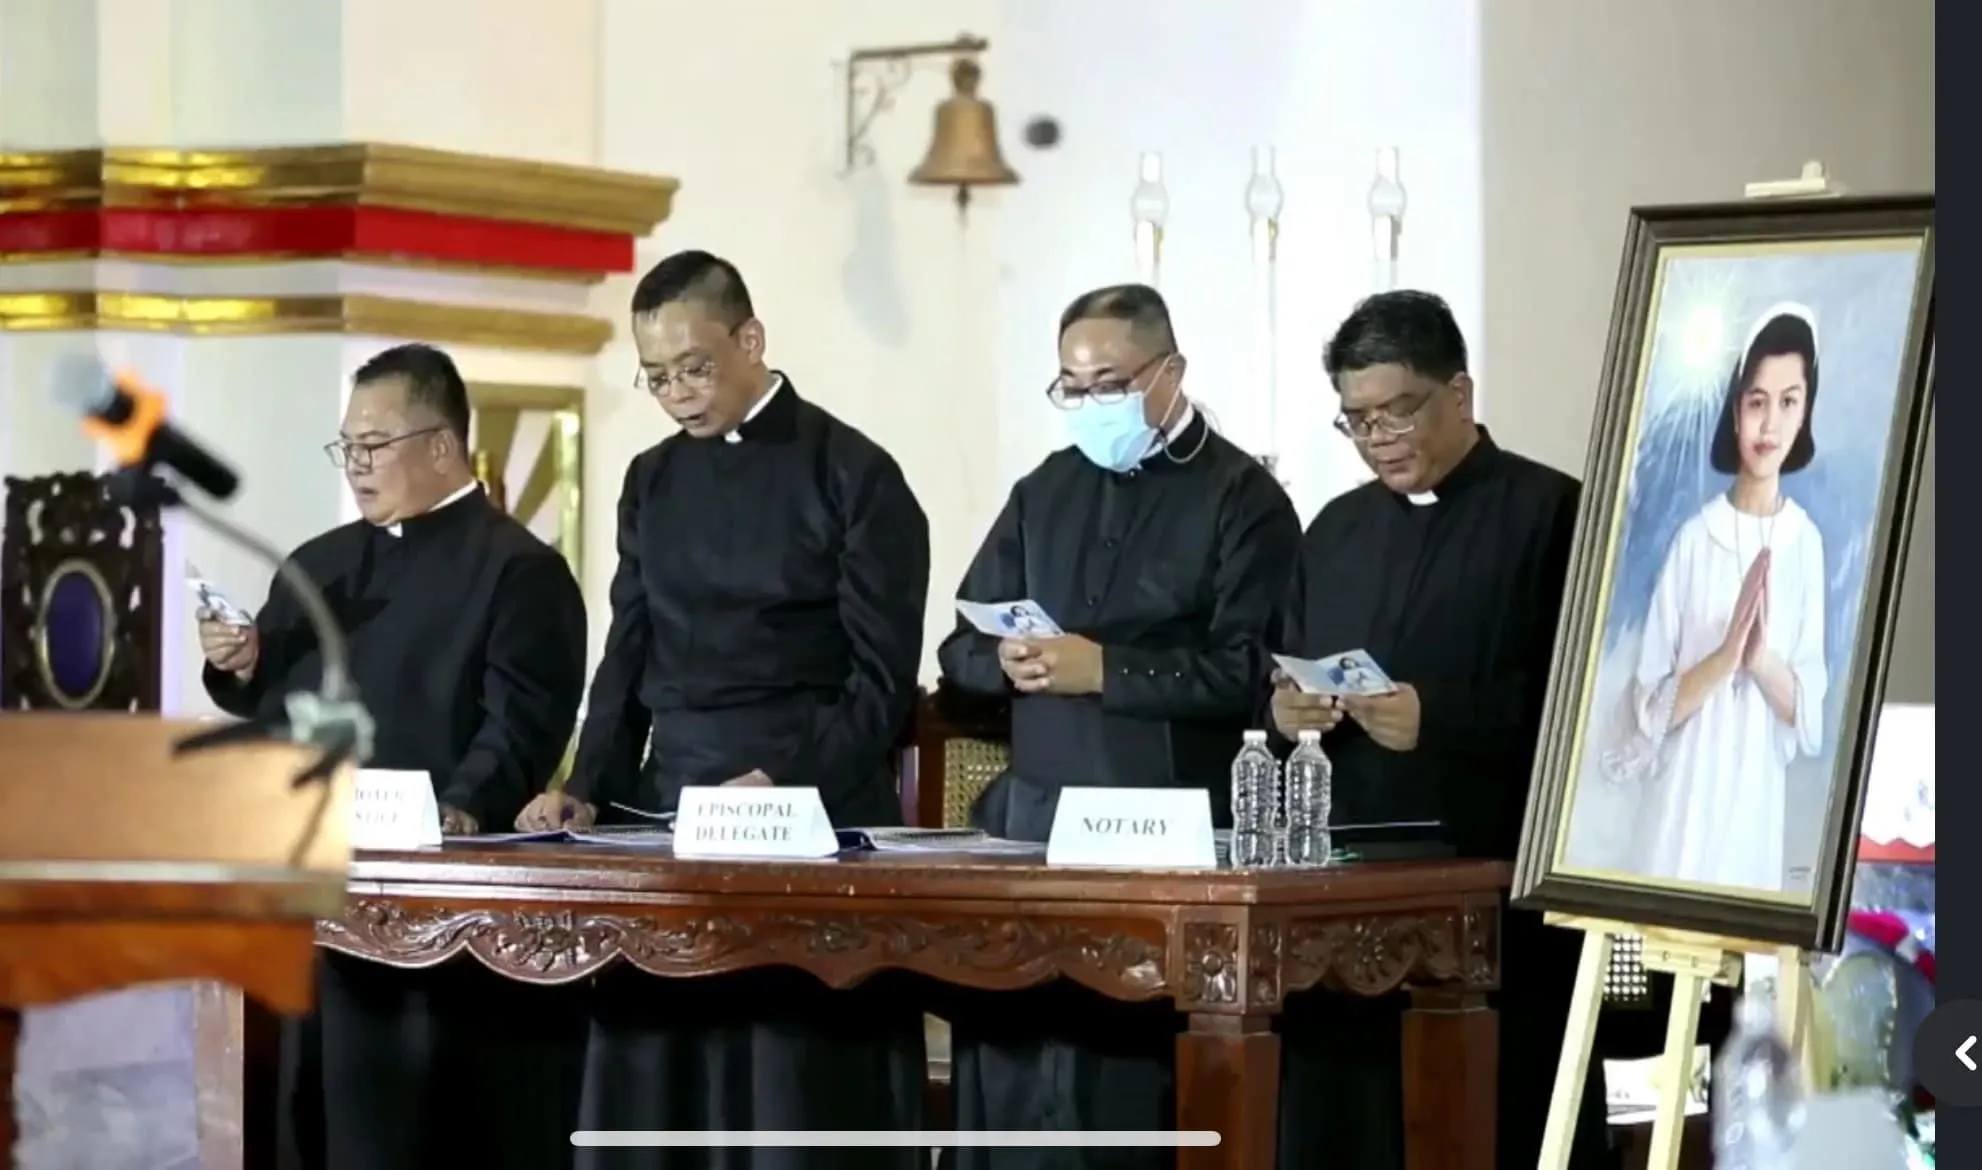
1481 0 1934 702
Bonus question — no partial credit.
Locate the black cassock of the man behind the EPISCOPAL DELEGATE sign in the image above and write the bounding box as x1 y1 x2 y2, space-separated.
567 375 930 1170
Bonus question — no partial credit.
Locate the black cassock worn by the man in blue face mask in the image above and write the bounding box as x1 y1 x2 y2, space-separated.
941 416 1300 1170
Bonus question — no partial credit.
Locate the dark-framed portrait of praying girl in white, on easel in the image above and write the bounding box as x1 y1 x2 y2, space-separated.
1514 196 1934 950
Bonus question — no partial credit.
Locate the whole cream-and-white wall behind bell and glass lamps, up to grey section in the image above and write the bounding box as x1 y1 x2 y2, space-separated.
587 0 1481 678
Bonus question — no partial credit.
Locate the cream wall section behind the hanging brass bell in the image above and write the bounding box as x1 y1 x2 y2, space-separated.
585 0 998 678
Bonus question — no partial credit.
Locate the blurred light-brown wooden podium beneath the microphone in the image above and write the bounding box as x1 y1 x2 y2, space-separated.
0 712 351 1166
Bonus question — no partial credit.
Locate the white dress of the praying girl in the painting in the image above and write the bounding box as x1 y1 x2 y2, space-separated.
1629 496 1825 890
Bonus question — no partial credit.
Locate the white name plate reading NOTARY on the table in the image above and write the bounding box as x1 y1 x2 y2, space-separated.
1046 787 1219 869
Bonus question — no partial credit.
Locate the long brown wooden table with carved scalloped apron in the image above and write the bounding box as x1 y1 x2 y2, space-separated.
317 845 1508 1170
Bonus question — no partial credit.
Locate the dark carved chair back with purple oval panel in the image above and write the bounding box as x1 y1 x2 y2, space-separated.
0 472 165 712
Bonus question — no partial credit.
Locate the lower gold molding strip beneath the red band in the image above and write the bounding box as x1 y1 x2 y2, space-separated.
0 292 612 357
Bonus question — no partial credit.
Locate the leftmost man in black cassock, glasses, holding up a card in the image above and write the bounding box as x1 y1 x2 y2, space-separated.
200 345 585 1170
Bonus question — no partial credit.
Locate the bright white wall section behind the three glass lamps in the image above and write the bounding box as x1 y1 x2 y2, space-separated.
987 0 1481 516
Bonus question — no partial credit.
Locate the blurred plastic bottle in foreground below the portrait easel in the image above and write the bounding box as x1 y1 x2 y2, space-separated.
1712 995 1804 1170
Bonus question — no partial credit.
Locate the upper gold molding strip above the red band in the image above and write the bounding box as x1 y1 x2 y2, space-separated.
0 143 680 240
